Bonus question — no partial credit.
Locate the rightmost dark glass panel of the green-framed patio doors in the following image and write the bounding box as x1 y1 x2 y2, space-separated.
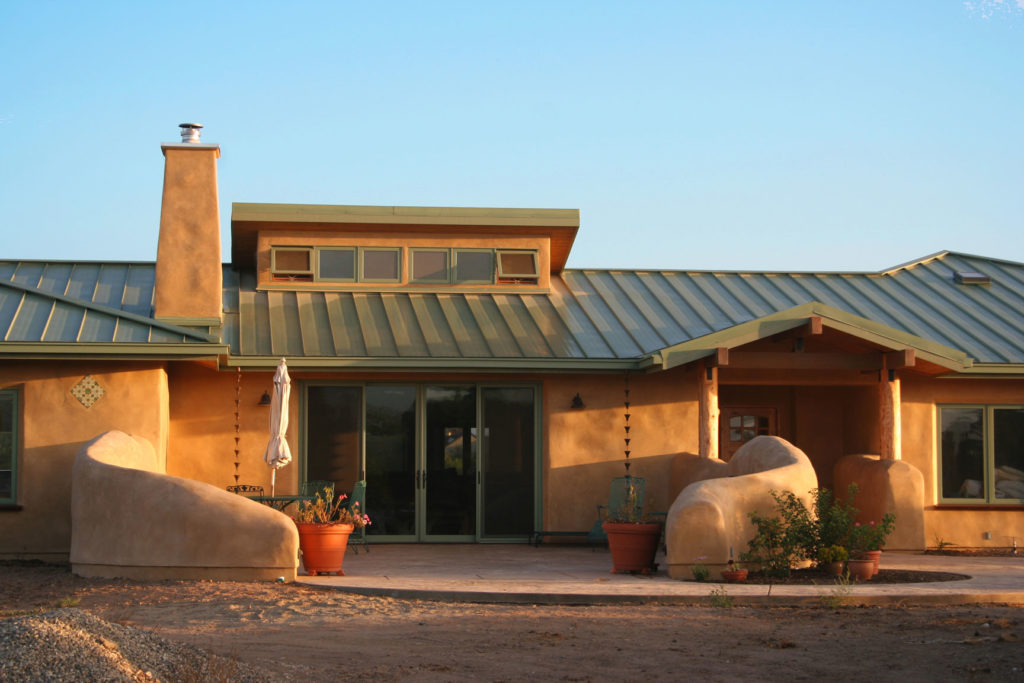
480 387 536 538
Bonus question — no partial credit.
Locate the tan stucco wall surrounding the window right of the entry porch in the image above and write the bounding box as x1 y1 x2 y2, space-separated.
897 379 1024 548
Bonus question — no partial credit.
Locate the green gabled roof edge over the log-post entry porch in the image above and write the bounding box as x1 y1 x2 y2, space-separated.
641 301 973 373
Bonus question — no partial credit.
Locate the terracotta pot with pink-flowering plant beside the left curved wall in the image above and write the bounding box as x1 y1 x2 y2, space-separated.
292 486 370 577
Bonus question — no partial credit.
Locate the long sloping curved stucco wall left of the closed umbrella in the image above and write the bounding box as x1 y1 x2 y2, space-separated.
71 431 299 581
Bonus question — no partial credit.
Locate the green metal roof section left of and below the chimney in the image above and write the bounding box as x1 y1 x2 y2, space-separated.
0 261 219 355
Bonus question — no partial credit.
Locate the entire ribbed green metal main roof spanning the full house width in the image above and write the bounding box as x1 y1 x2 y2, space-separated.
0 252 1024 374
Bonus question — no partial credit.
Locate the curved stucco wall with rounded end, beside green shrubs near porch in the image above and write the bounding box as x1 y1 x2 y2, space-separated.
665 436 818 579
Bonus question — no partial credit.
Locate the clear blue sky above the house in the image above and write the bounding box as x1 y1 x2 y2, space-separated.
0 0 1024 270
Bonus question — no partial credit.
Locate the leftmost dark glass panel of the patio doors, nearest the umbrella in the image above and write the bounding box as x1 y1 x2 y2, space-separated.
306 386 362 494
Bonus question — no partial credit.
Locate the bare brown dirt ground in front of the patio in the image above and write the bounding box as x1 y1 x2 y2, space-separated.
0 564 1024 681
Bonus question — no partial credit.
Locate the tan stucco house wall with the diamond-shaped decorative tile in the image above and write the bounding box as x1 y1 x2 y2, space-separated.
0 360 168 562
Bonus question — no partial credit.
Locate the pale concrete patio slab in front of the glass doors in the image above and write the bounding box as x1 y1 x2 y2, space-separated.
296 544 1024 606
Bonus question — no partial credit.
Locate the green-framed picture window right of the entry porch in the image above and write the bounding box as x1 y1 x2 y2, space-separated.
939 405 1024 504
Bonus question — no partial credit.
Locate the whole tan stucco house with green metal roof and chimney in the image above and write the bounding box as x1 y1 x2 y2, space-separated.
0 128 1024 561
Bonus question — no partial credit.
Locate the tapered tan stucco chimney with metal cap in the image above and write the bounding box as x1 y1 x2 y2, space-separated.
154 123 223 326
